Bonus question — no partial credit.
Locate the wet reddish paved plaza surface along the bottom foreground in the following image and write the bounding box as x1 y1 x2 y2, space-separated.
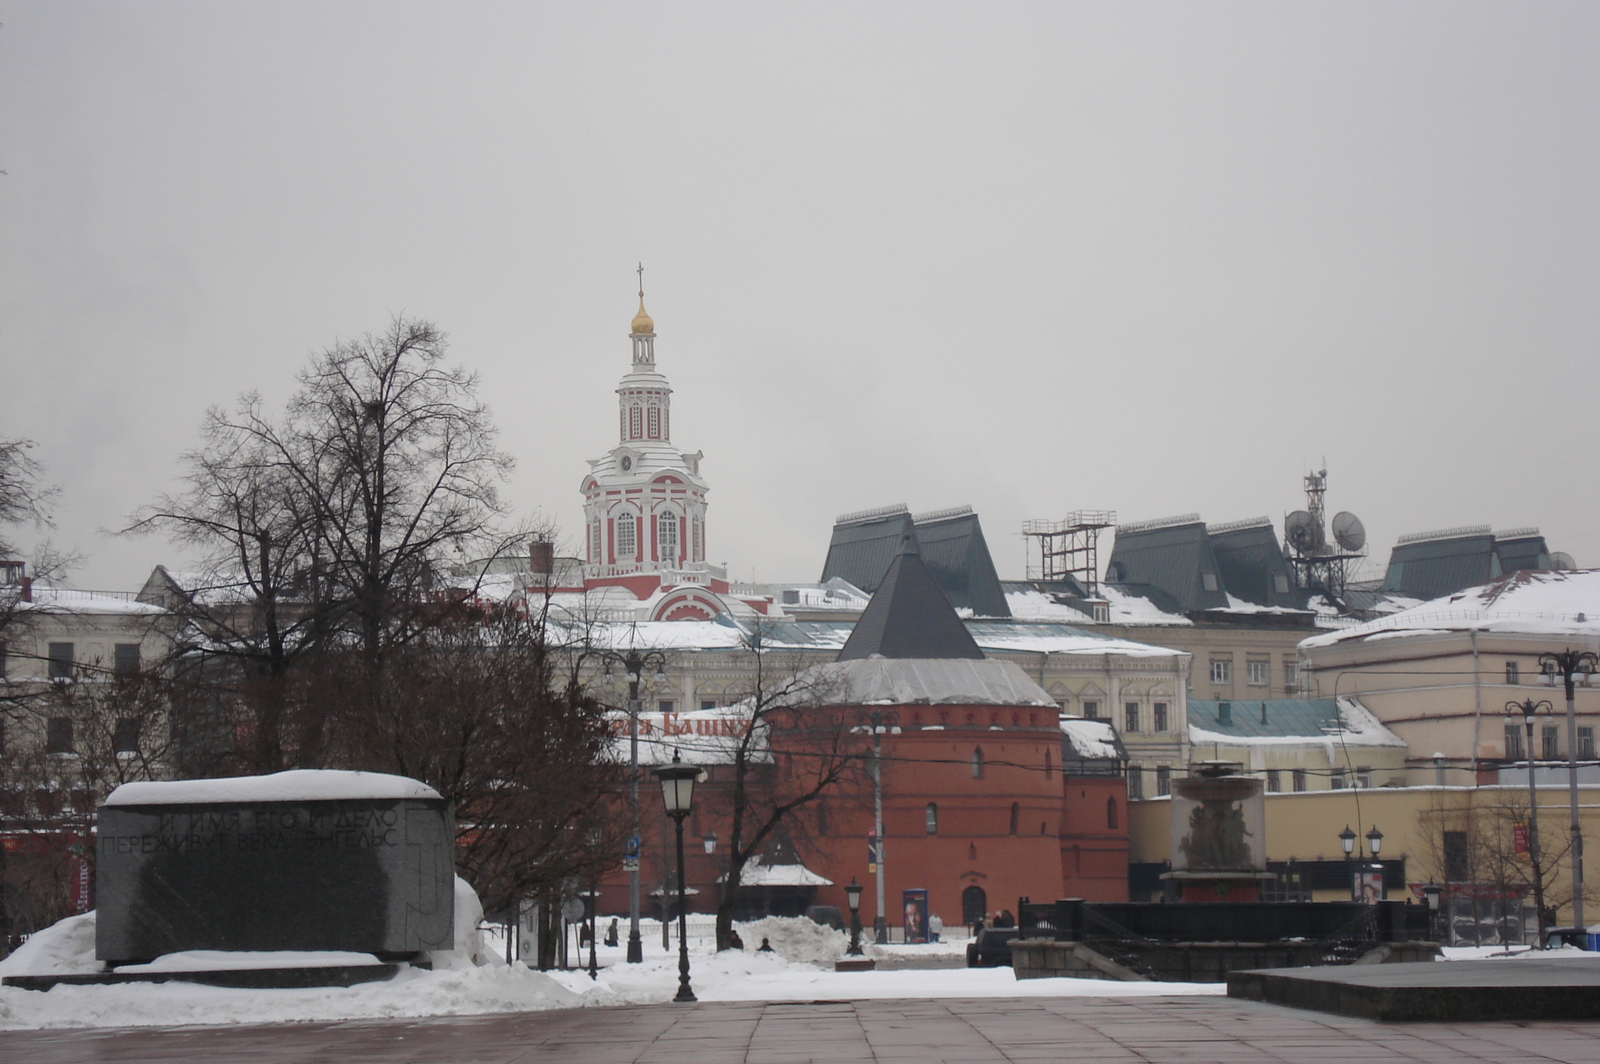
0 997 1600 1064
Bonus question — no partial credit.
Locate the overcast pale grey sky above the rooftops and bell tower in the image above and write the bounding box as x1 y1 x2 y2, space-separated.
0 0 1600 589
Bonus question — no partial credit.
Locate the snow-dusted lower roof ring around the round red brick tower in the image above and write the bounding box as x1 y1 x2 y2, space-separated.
816 658 1054 707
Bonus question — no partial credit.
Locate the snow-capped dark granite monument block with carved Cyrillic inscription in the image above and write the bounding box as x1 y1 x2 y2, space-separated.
94 770 454 965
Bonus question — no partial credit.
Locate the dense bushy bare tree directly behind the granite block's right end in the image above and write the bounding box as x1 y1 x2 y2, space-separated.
322 603 622 912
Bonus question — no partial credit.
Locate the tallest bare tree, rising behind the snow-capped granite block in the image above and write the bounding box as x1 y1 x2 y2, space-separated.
128 318 526 771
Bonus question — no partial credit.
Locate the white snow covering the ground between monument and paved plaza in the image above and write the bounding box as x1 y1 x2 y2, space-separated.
0 914 1222 1029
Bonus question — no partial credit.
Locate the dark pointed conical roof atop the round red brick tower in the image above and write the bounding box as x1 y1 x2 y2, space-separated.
838 533 984 661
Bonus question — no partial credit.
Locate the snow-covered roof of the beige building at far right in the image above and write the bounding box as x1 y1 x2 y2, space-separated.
1301 570 1600 648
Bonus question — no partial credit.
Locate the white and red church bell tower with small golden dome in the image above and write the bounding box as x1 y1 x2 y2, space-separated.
581 293 771 621
